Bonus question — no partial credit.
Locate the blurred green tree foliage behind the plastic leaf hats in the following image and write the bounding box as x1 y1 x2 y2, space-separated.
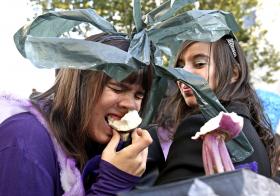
30 0 280 83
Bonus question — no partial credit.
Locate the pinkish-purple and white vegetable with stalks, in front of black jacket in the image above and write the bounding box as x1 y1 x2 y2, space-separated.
192 112 243 175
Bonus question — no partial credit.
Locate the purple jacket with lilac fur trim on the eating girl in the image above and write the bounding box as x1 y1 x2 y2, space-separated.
0 95 139 196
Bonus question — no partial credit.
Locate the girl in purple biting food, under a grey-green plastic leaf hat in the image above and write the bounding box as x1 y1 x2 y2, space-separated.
0 10 152 196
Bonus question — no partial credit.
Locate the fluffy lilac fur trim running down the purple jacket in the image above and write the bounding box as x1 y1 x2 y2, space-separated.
0 94 85 196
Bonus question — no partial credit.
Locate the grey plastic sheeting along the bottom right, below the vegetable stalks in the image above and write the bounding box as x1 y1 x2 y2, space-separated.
119 169 280 196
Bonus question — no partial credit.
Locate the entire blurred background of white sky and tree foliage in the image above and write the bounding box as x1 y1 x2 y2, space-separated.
0 0 280 132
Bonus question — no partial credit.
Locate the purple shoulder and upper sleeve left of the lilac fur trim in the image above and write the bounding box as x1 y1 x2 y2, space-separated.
0 113 62 196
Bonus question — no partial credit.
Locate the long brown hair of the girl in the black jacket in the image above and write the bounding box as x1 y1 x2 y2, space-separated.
167 36 277 175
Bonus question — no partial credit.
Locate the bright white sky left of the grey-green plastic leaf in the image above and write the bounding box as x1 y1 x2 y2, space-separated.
0 0 54 97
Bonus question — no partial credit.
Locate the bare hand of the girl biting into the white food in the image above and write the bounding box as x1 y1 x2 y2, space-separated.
101 128 153 176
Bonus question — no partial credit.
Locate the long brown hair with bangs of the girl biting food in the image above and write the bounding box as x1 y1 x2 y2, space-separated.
32 33 152 168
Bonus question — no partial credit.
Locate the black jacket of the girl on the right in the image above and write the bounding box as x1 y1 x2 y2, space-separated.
156 103 271 184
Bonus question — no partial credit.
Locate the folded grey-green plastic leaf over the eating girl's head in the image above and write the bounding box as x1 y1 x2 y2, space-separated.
14 9 146 81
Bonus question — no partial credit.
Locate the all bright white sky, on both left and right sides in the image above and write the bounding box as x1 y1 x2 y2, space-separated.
0 0 280 97
